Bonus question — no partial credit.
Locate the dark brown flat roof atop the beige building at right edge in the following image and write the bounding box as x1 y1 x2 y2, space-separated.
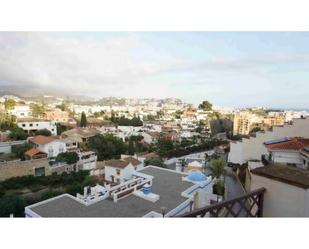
251 165 309 189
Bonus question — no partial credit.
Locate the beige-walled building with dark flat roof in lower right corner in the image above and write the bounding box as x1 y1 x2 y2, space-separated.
250 165 309 217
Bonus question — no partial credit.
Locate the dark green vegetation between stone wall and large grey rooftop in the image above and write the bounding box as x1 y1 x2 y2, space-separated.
0 171 96 217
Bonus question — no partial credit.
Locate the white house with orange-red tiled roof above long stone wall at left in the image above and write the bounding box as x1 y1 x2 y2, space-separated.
26 135 67 158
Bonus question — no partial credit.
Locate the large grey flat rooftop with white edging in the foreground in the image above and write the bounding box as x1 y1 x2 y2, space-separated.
30 166 193 217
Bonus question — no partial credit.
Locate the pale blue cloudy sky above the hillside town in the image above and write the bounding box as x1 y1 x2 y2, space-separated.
0 32 309 109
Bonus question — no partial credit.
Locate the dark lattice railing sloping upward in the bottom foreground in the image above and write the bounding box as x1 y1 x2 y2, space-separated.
178 188 266 217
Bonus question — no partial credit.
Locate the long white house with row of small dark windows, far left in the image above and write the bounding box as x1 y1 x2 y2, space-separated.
17 118 57 136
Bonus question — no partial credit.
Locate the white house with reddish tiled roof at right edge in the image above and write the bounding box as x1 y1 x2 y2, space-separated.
264 137 309 169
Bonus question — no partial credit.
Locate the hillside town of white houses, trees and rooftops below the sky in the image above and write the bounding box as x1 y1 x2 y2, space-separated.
0 94 309 217
